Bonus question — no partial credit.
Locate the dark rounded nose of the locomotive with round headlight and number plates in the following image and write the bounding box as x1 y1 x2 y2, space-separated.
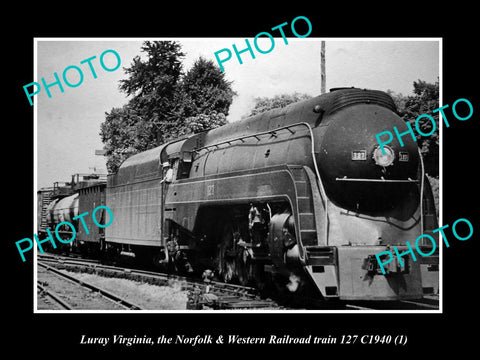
317 93 419 217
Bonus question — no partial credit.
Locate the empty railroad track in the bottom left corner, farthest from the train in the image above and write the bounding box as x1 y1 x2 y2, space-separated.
37 261 142 310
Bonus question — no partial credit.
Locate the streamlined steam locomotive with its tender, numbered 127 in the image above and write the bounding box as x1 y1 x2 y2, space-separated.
105 88 438 300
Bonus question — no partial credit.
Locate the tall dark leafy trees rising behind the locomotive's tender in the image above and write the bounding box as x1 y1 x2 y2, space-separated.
100 41 235 172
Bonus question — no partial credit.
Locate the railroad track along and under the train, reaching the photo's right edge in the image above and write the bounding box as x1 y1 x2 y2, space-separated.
38 254 439 311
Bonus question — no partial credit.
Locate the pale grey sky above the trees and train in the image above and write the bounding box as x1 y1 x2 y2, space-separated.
34 37 441 188
